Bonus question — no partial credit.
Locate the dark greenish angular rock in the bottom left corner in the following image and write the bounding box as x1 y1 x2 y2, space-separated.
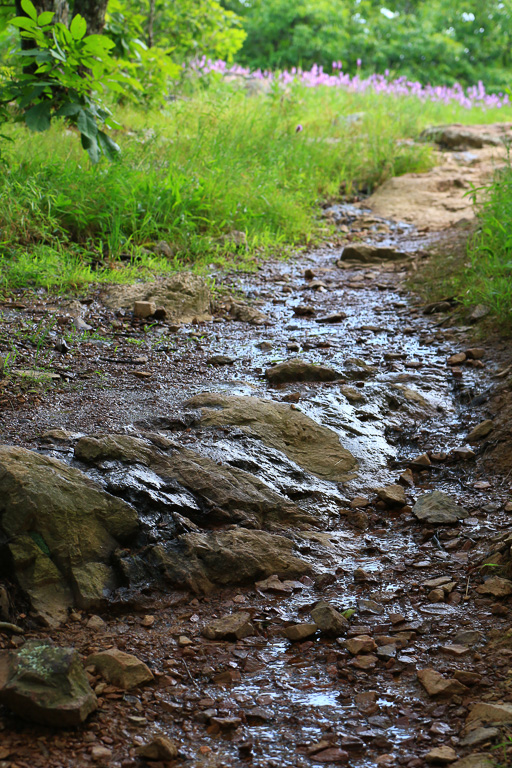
0 640 98 728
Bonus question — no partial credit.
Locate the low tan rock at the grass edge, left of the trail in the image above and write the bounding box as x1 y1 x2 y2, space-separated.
101 272 212 323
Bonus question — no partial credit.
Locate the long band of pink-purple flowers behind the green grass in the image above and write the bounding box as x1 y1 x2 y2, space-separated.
192 57 510 109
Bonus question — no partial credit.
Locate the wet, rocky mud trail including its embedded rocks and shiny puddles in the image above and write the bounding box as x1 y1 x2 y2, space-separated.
0 126 512 768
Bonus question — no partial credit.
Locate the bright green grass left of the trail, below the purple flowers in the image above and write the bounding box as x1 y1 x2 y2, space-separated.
0 79 510 291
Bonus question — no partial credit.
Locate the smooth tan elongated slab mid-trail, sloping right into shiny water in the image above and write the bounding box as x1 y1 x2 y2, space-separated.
185 393 357 481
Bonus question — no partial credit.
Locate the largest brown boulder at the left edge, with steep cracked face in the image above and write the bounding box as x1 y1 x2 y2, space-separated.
0 446 139 626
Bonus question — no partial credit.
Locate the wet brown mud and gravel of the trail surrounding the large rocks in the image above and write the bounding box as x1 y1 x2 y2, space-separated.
0 126 512 768
